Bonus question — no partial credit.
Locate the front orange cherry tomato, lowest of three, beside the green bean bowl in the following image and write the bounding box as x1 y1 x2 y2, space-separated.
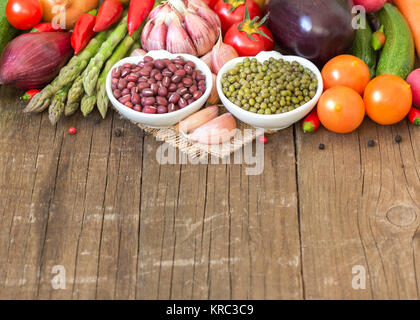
317 86 365 133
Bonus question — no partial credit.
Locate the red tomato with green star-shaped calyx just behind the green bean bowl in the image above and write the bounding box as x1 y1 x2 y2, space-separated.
225 9 274 57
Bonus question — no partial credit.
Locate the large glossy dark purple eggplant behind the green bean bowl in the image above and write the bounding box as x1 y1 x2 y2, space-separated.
266 0 355 67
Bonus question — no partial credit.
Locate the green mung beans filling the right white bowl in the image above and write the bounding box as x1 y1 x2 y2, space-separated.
222 58 318 115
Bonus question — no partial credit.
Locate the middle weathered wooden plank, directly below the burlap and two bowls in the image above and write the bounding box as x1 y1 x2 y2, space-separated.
137 129 303 299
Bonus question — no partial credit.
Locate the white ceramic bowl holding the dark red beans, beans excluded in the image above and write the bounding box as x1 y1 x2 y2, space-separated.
106 50 213 128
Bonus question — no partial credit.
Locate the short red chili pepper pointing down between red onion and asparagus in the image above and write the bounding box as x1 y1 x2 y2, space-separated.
71 10 97 54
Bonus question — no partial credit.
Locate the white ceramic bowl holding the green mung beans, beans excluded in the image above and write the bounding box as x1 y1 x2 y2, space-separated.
217 51 324 130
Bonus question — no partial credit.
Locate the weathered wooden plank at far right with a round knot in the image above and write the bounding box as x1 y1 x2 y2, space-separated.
298 120 420 299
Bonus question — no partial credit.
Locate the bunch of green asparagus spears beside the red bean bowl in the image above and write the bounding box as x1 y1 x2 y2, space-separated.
24 16 141 124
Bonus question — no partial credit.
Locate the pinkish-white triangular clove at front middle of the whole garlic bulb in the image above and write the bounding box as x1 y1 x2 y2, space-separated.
166 16 197 56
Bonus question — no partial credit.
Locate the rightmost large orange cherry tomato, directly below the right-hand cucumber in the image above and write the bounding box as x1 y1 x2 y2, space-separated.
364 74 413 125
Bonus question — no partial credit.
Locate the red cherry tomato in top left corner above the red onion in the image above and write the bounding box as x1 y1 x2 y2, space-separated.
6 0 42 30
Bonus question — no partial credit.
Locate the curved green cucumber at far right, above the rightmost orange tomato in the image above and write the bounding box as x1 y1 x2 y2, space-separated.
376 3 415 80
